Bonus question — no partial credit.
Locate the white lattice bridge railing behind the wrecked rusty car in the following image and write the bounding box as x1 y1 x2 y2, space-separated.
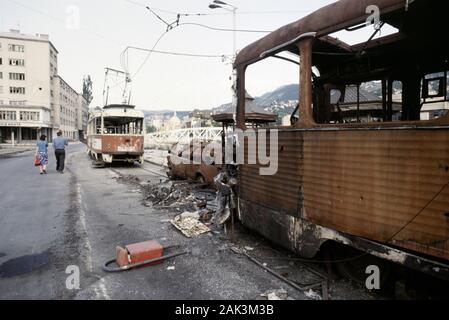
145 127 223 148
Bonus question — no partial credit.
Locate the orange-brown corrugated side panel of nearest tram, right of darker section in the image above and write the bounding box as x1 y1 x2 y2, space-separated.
302 130 449 258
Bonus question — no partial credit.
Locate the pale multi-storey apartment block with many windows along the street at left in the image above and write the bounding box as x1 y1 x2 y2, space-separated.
0 30 88 143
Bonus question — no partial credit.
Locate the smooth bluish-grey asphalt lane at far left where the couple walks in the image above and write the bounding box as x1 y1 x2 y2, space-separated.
0 144 83 299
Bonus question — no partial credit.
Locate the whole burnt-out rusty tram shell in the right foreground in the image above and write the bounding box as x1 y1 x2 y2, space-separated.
234 0 449 280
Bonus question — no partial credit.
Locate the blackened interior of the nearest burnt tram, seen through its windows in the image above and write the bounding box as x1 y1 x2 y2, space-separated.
245 1 449 126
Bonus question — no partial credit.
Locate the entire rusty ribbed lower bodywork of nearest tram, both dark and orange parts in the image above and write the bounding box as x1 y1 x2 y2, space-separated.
239 129 449 259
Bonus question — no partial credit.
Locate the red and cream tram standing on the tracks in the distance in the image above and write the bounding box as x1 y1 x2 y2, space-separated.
87 105 145 164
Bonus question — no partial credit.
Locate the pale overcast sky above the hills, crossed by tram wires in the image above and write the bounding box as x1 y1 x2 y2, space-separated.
0 0 394 110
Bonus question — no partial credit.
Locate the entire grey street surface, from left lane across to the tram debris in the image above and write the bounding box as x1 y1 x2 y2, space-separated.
0 144 372 300
